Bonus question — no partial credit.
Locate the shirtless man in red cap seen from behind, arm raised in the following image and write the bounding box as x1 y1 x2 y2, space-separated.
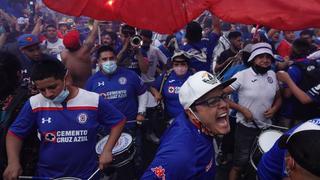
61 21 98 87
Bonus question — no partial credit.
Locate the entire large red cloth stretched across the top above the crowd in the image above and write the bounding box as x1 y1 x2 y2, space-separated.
43 0 320 34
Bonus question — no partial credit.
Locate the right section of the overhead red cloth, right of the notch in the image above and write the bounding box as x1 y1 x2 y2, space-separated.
210 0 320 30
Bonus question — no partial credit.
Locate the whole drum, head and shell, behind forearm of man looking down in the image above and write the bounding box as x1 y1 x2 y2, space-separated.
96 133 136 167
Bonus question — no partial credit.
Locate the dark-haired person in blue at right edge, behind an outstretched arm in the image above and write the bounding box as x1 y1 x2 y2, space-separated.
278 39 320 127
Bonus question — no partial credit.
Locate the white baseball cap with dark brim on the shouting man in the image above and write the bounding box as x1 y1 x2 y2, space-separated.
179 71 236 109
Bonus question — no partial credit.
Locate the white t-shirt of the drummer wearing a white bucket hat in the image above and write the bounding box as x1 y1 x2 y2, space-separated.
230 68 279 128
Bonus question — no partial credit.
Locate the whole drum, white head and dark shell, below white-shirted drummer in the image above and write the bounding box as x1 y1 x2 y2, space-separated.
250 129 283 170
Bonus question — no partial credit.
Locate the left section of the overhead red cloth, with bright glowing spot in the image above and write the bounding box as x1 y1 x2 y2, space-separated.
44 0 207 34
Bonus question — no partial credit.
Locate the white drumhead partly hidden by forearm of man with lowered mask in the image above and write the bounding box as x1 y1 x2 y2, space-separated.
96 133 132 154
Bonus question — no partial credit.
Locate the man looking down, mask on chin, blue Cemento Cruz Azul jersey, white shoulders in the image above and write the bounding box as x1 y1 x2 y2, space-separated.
3 59 125 180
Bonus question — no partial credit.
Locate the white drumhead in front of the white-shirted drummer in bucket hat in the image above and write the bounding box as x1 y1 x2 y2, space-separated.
258 129 283 153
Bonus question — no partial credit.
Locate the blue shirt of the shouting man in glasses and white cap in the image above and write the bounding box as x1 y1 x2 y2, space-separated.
141 113 215 180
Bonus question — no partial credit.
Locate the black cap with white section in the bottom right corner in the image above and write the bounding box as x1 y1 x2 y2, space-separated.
278 119 320 177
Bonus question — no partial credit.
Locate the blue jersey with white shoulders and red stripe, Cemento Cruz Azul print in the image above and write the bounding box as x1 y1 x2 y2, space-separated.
9 89 125 179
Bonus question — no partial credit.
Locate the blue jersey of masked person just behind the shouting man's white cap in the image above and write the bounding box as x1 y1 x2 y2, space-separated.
152 71 191 118
